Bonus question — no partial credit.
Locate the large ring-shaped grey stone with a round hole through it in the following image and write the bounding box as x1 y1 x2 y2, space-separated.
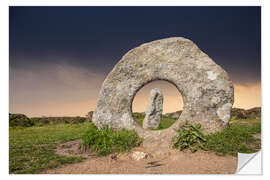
92 37 234 146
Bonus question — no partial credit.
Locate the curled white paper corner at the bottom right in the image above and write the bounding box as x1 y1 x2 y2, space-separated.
235 151 262 175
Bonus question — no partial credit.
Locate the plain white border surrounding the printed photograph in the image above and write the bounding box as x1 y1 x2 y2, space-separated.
0 0 270 180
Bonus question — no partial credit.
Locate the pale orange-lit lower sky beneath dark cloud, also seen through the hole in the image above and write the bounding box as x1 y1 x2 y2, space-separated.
9 65 261 117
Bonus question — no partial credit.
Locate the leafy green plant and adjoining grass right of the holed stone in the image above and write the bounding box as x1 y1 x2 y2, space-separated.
173 119 261 156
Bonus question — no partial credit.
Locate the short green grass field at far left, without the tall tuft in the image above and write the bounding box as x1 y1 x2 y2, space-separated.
9 122 92 174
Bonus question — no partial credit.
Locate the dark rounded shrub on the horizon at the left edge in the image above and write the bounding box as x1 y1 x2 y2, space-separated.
9 113 34 127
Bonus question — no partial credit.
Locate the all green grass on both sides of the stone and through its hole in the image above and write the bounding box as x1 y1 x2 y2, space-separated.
9 114 261 174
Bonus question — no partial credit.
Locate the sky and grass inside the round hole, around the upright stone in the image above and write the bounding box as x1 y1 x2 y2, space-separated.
132 80 183 130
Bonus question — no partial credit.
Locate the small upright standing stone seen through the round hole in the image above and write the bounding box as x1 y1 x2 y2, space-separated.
143 88 163 129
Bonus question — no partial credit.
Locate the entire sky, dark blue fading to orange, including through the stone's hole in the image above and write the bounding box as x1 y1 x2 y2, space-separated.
9 7 261 117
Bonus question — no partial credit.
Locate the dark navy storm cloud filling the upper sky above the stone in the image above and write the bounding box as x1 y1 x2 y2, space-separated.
10 7 261 84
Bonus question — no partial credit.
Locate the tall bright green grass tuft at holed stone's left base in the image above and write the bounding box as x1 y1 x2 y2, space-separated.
81 125 142 155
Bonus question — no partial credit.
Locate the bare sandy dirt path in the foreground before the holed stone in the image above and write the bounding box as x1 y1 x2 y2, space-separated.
42 141 237 174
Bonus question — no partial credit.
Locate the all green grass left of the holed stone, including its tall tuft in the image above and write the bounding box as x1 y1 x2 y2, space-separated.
9 122 142 174
